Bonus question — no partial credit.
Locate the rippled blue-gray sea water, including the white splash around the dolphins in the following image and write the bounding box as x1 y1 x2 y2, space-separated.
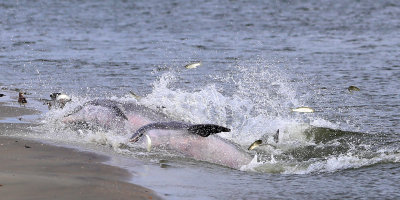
0 0 400 199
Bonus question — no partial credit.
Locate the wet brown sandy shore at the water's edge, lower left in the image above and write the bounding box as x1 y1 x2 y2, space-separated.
0 99 160 200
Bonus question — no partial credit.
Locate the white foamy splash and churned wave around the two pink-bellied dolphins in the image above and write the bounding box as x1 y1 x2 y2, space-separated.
33 60 399 174
